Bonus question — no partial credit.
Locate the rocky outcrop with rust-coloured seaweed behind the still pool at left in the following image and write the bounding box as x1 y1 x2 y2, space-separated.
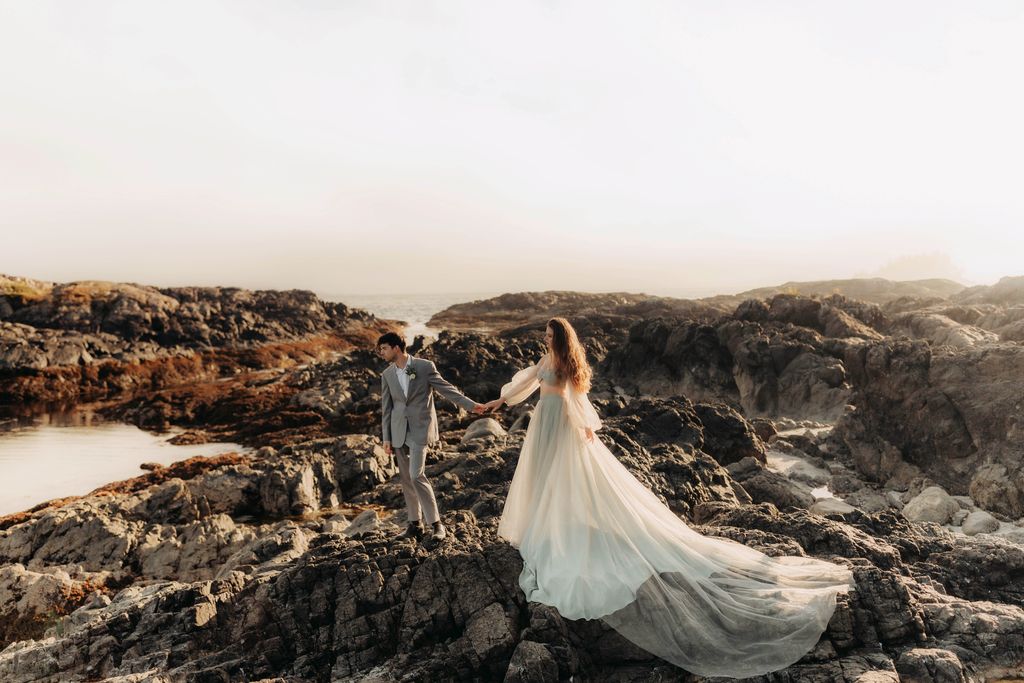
0 275 391 407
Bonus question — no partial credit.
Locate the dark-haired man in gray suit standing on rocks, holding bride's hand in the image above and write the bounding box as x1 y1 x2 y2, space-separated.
377 332 484 541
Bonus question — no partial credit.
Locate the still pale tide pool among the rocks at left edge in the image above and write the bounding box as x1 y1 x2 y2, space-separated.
0 408 249 515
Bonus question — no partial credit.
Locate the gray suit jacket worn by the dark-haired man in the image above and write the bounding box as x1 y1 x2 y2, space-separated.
381 356 475 446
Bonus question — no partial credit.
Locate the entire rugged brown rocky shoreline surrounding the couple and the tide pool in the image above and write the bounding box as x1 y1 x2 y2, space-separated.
0 278 1024 683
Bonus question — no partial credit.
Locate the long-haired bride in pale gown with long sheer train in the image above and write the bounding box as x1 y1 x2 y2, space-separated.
485 317 855 678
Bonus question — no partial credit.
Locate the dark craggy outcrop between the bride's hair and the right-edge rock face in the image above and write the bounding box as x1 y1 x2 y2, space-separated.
601 295 864 420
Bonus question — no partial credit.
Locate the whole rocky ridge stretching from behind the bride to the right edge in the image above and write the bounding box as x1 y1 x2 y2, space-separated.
600 286 1024 518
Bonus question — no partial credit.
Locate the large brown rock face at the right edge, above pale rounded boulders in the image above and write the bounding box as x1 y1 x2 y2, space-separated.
836 341 1024 518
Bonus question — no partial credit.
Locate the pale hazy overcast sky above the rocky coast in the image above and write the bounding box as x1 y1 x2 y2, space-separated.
0 0 1024 295
